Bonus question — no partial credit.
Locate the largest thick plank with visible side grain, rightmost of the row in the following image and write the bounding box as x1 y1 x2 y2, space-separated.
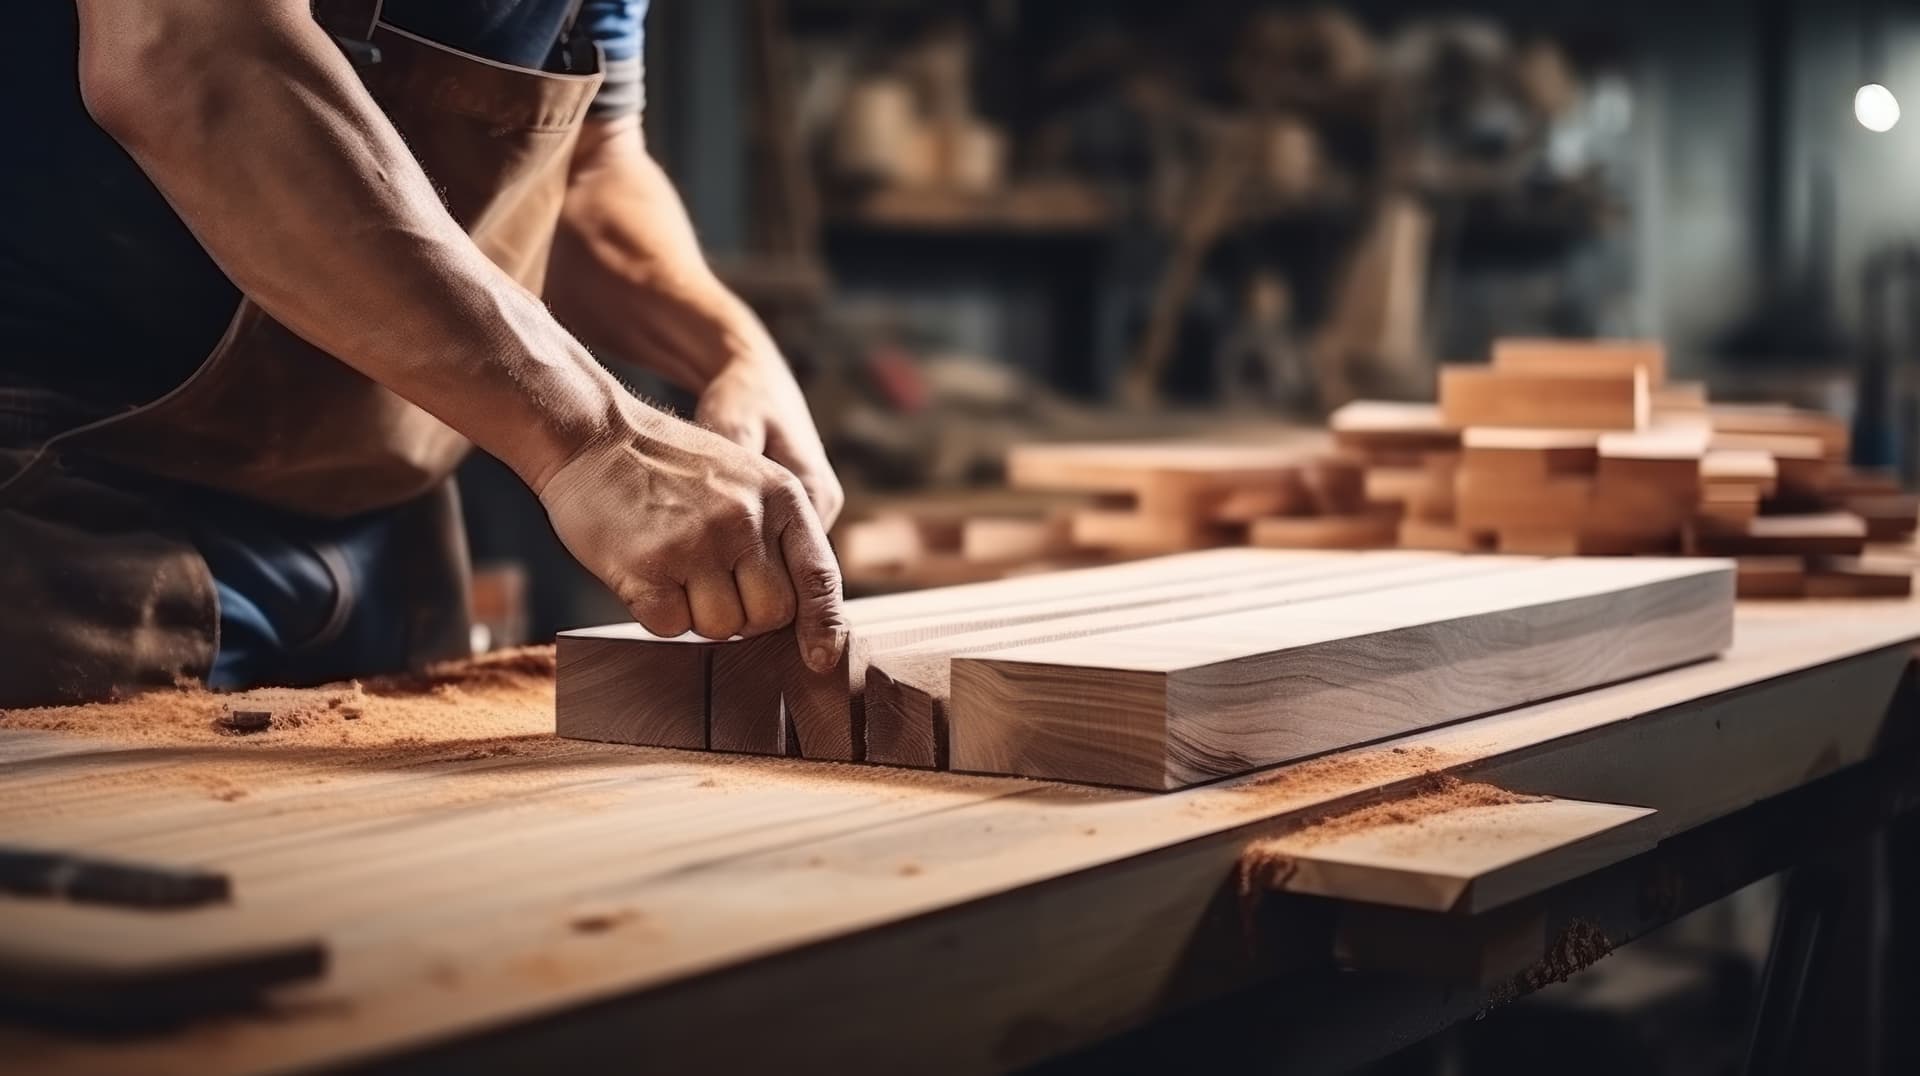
948 559 1734 790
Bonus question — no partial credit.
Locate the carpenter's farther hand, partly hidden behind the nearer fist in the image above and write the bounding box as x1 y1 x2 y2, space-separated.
693 327 847 528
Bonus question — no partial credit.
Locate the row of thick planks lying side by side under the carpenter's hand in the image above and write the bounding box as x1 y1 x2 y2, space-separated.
557 550 1734 790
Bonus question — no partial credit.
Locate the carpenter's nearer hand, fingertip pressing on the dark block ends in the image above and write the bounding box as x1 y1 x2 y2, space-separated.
538 407 847 673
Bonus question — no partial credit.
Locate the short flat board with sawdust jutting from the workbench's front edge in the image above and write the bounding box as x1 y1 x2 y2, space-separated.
1246 795 1655 915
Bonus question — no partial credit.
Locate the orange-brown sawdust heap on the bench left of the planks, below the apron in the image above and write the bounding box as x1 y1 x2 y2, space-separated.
0 646 555 749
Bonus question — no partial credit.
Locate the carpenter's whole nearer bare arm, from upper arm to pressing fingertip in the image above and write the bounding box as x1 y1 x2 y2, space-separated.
77 0 845 661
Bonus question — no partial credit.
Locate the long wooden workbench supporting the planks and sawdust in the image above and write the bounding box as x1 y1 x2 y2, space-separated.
0 601 1920 1072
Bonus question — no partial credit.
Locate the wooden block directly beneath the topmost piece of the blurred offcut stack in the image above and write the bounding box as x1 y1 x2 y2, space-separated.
1440 367 1649 430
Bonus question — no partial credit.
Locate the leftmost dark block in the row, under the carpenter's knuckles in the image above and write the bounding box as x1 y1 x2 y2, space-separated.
553 624 720 749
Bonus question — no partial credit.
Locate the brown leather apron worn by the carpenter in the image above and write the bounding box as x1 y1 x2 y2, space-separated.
0 0 601 707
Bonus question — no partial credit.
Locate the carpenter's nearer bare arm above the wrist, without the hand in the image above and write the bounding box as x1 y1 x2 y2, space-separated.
79 0 632 488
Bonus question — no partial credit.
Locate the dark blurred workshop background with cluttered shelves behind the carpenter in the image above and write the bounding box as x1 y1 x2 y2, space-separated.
362 0 1920 1074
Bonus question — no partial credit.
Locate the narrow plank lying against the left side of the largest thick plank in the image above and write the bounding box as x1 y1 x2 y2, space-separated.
866 553 1505 769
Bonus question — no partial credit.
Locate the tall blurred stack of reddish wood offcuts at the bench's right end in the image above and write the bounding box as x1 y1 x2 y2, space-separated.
1332 340 1920 598
